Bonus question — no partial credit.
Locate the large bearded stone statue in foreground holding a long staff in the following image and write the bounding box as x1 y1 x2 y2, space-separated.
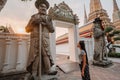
26 0 57 80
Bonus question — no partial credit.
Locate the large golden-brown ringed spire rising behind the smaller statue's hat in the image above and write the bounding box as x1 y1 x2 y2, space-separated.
88 0 112 28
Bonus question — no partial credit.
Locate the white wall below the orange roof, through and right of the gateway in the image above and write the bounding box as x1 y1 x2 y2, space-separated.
56 38 94 60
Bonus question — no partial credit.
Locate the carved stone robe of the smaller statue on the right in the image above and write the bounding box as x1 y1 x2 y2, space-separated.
93 26 107 61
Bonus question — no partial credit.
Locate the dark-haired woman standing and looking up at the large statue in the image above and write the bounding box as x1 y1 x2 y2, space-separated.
77 41 90 80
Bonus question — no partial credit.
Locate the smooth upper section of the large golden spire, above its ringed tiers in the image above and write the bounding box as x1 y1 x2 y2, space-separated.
90 0 102 13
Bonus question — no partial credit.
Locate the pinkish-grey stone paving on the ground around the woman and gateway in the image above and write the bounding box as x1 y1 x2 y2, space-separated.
57 56 120 80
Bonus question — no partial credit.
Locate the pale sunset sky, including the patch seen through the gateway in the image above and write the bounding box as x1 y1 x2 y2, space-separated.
0 0 120 37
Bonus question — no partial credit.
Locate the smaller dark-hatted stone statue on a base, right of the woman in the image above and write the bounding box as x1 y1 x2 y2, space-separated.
93 18 111 66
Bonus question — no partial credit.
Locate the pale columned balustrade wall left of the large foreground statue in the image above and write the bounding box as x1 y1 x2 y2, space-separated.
0 33 30 73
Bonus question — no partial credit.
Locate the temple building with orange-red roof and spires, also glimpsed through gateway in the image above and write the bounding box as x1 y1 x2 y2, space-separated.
56 0 120 44
